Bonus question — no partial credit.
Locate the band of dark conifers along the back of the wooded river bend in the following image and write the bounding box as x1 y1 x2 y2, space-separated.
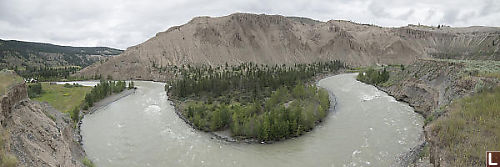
167 60 345 98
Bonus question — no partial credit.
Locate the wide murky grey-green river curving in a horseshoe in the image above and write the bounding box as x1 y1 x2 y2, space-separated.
81 74 423 167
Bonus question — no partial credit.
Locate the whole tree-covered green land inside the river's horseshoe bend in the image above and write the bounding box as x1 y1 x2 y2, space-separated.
165 61 345 142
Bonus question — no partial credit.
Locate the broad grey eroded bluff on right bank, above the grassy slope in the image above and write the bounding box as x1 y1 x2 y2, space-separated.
379 60 498 117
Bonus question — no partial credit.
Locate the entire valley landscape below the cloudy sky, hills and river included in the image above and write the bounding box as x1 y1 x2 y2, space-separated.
0 13 500 167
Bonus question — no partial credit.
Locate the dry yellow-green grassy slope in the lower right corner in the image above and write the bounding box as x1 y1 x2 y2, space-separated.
432 86 500 166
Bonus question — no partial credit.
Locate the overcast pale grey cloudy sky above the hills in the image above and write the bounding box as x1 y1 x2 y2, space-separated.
0 0 500 49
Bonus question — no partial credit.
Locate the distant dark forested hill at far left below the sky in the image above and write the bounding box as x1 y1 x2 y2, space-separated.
0 40 122 70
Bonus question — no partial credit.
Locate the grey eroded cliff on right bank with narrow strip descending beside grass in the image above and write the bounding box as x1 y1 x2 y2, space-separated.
379 60 500 166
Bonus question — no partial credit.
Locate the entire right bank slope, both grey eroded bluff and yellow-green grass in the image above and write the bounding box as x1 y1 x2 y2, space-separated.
360 59 500 166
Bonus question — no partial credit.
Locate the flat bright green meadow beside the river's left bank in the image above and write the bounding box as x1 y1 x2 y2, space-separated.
34 83 92 112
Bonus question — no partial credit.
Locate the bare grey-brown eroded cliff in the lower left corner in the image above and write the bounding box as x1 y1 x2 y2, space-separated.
1 83 84 167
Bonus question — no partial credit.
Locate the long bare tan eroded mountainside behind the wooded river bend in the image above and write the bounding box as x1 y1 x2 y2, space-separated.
78 13 500 80
